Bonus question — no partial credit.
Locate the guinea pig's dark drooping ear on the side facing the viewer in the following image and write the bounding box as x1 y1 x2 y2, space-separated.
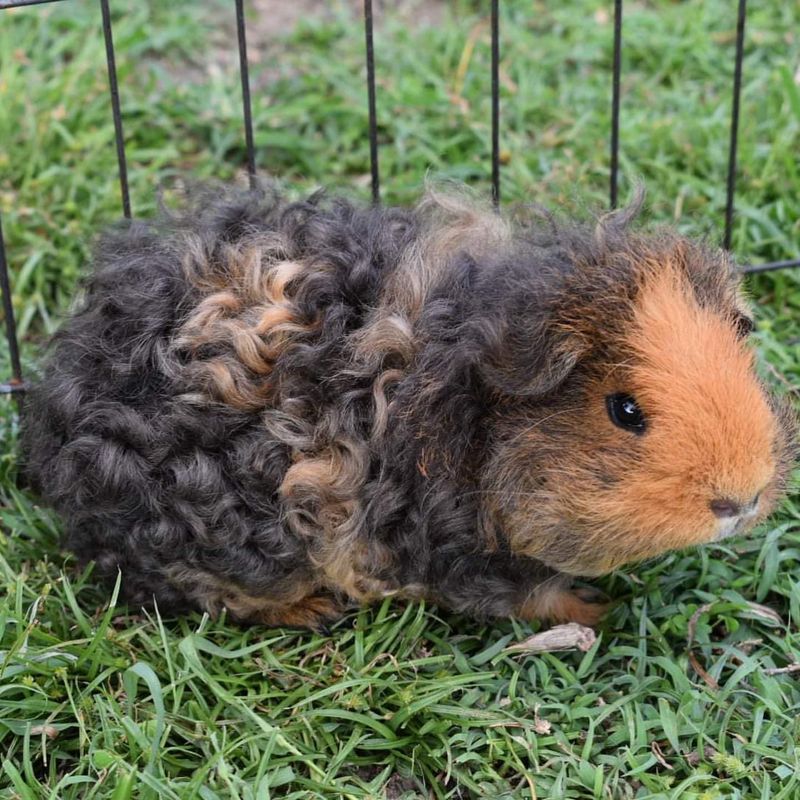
478 326 590 397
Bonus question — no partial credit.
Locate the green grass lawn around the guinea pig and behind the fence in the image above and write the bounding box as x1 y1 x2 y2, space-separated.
0 0 800 800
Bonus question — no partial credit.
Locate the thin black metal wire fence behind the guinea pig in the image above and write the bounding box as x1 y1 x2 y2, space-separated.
0 0 800 395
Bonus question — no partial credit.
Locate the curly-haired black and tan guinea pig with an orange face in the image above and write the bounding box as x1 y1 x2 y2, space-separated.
18 183 796 627
